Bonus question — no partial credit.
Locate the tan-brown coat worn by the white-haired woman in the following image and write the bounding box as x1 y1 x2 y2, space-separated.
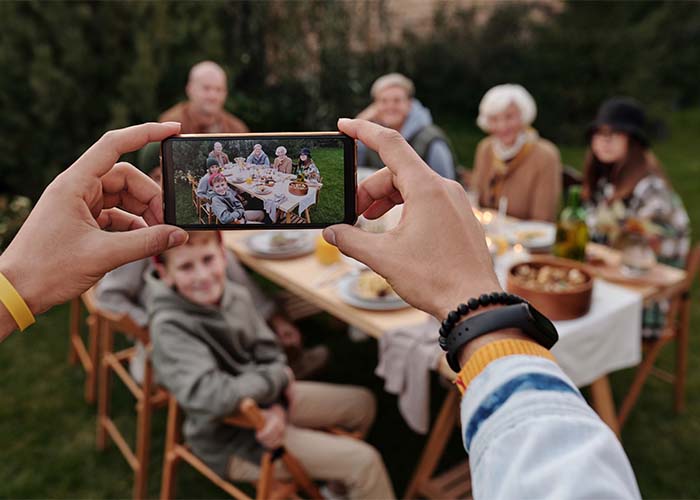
470 137 562 221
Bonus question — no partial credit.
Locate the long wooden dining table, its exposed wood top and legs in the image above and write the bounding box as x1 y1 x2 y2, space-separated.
224 231 685 498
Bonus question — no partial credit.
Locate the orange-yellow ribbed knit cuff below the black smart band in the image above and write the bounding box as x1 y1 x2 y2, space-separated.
453 339 556 394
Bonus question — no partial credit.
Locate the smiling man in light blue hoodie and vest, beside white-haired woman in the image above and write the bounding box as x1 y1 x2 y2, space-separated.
357 73 455 179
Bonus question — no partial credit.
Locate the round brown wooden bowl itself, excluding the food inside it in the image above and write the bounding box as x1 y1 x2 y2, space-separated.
506 259 593 321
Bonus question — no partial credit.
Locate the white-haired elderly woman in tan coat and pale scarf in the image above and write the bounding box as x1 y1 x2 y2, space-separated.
470 84 562 221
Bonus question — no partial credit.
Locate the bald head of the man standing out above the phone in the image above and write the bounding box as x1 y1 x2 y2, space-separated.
185 61 228 117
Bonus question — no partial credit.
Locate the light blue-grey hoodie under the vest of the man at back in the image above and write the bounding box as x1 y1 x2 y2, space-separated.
357 99 455 179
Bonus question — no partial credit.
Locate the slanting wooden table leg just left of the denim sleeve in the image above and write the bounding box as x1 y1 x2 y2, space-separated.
403 389 460 499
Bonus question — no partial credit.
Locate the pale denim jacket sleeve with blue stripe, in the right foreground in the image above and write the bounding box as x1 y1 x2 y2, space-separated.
461 355 640 499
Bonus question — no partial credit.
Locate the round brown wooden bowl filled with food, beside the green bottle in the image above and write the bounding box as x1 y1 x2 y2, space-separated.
506 259 593 321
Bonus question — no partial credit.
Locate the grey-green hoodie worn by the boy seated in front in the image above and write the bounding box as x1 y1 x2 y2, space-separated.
146 273 289 475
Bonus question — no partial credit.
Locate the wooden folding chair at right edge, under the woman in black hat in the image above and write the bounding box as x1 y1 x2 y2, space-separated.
617 243 700 428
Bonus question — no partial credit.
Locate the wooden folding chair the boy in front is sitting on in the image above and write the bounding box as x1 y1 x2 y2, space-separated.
160 396 322 500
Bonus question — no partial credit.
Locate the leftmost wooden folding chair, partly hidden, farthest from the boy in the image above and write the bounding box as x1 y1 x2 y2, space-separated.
68 288 100 404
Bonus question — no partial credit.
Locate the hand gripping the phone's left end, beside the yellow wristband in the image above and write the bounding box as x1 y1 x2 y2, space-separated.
0 122 187 314
